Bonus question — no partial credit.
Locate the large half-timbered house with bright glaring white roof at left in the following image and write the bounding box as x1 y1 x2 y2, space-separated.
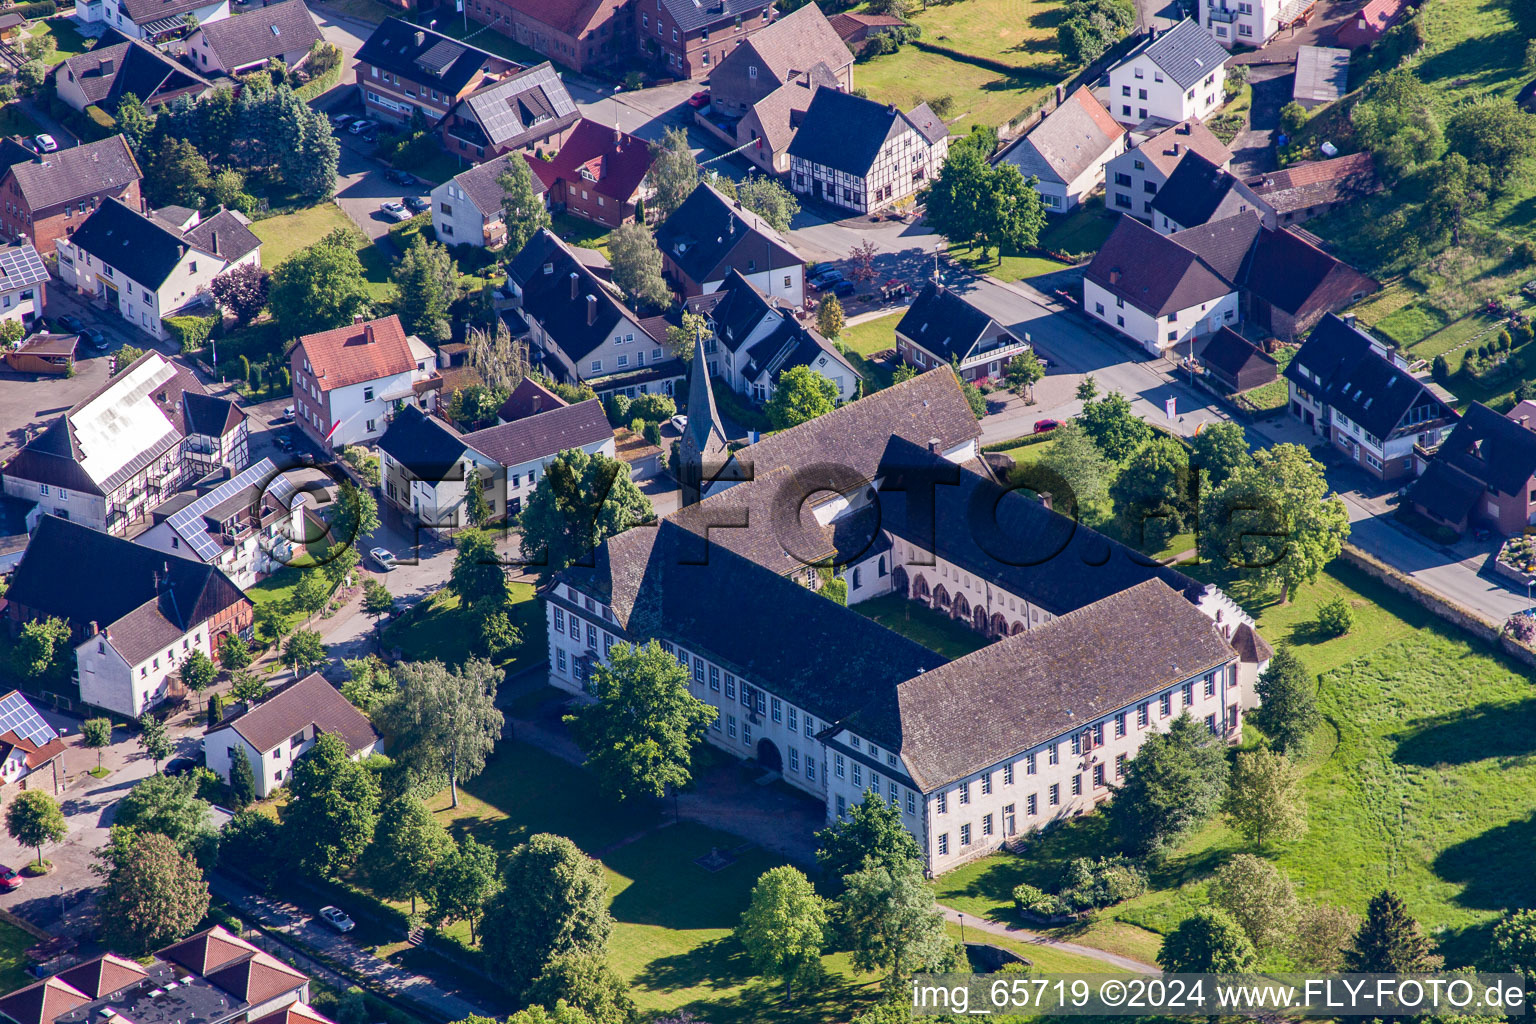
5 352 244 533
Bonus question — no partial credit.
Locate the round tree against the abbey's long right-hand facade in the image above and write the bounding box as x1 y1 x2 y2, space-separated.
1109 711 1227 854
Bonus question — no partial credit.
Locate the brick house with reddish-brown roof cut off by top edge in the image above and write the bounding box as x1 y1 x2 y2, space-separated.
464 0 636 74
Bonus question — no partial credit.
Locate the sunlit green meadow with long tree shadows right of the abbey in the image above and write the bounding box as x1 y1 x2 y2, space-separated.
935 552 1536 966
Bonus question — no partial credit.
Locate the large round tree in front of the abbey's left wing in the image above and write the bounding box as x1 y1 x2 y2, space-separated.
565 640 719 800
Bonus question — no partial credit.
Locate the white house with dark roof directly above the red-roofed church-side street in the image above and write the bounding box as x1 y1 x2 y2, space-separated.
656 181 805 306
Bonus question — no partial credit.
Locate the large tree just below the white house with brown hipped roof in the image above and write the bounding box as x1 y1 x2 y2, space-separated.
278 732 379 878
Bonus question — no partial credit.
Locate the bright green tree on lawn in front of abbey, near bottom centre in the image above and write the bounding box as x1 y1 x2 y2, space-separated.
736 864 828 999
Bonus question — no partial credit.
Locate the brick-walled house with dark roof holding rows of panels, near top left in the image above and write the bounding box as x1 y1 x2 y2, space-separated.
353 18 522 124
